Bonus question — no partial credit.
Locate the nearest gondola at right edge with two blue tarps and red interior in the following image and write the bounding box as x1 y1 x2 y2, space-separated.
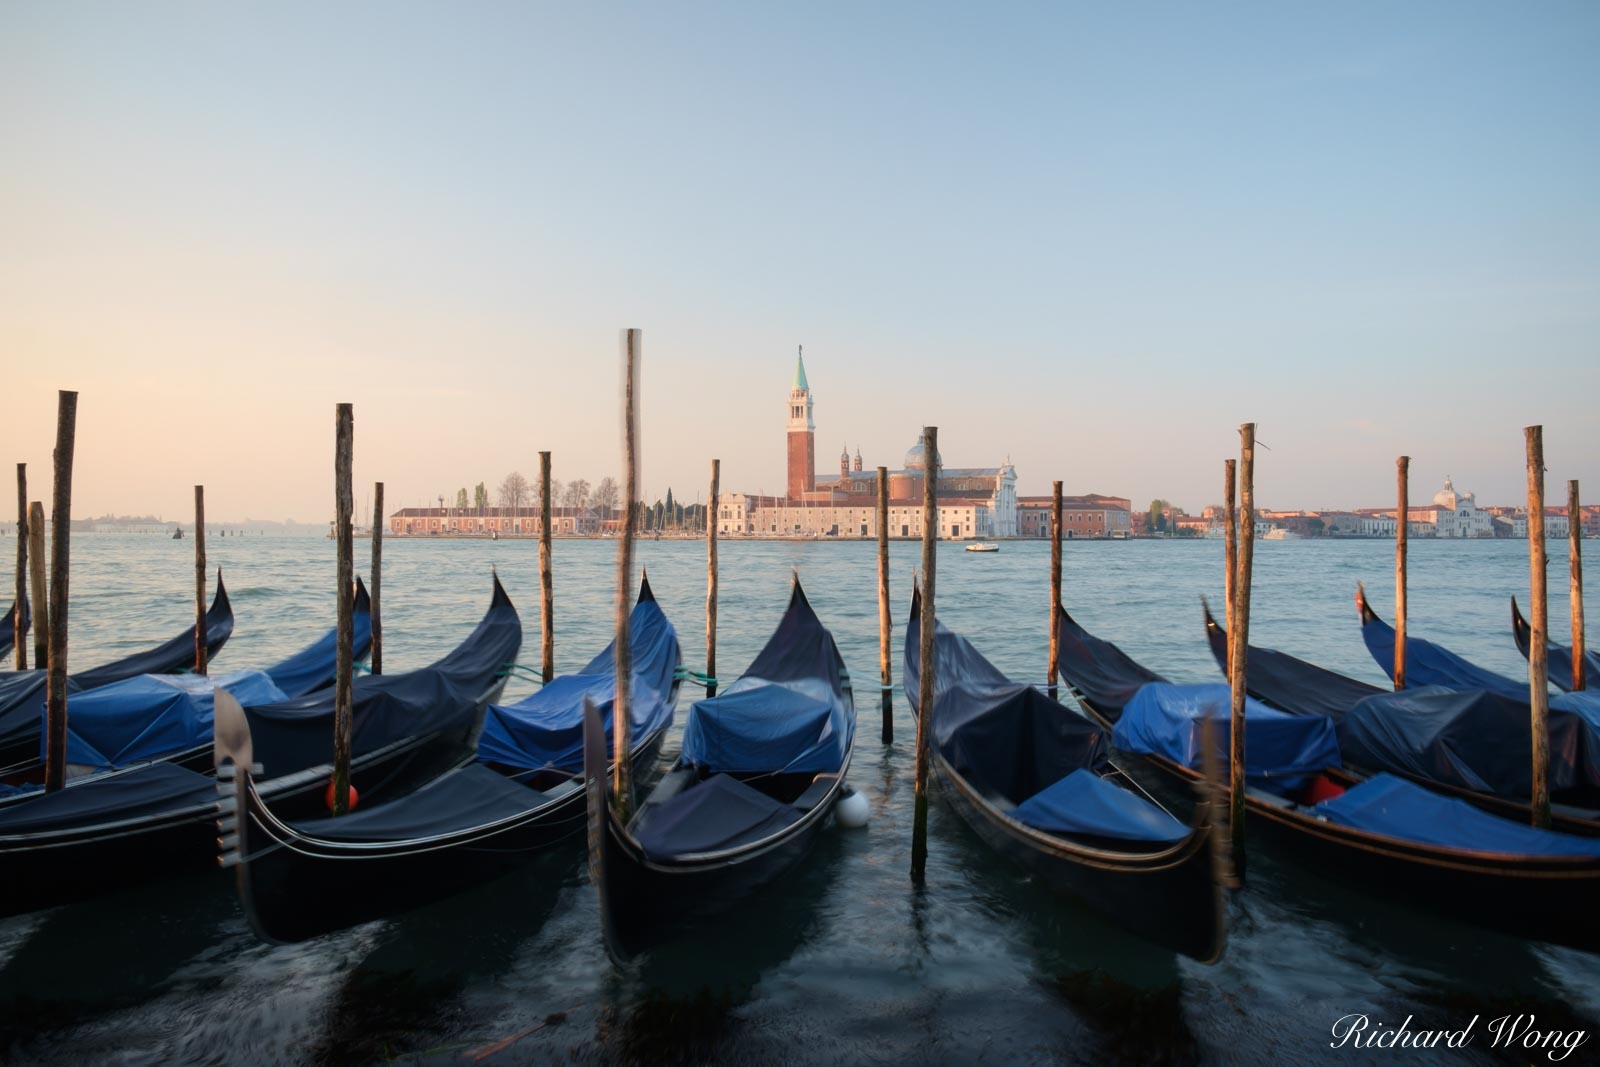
1061 607 1600 952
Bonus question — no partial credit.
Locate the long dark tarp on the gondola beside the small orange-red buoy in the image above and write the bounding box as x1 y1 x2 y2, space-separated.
245 577 522 777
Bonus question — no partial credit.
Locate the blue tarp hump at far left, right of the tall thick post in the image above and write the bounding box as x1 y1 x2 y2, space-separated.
60 670 286 766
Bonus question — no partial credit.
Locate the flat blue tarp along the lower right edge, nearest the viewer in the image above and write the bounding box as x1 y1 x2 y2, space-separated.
1312 774 1600 856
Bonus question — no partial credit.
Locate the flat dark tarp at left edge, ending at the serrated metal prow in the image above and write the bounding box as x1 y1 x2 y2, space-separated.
0 763 216 837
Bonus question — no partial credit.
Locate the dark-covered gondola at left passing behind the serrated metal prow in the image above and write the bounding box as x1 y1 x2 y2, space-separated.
0 577 522 915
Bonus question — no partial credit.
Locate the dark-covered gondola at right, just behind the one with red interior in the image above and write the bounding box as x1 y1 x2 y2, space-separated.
1202 601 1600 837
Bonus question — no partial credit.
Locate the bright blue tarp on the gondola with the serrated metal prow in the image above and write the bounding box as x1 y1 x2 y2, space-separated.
478 593 683 774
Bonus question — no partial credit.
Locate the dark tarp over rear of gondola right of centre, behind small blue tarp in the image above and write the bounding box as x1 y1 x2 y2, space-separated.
904 606 1107 806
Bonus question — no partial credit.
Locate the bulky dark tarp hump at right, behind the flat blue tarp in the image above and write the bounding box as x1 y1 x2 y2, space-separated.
1339 686 1600 808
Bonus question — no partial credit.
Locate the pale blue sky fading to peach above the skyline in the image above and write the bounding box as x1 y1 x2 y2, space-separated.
0 0 1600 522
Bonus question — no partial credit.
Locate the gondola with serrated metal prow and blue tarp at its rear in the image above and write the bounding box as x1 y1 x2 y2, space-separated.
216 579 683 942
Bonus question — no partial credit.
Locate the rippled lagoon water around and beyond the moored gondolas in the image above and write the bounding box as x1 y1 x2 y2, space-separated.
0 534 1600 1064
